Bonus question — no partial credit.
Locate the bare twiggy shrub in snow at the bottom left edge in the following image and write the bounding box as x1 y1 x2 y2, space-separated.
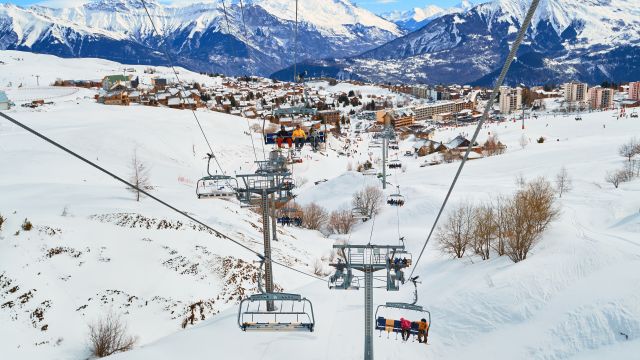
89 314 138 358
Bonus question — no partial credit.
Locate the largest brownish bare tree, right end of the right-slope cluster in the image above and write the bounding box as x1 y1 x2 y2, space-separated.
506 178 559 262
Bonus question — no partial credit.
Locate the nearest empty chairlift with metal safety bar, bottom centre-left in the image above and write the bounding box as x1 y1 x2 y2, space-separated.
238 257 315 332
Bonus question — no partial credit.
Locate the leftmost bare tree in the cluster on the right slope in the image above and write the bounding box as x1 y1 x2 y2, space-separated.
436 204 473 259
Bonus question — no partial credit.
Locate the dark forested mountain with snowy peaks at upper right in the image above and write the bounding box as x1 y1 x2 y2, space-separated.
284 0 640 85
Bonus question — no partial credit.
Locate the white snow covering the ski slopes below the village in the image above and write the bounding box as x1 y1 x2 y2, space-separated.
0 51 640 360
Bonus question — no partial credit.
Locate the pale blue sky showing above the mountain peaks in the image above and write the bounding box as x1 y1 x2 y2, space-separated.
0 0 480 14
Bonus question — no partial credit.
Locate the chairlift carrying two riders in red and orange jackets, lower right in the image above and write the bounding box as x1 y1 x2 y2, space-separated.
374 276 431 342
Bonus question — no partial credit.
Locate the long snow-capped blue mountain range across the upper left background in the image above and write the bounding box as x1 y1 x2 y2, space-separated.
0 0 402 75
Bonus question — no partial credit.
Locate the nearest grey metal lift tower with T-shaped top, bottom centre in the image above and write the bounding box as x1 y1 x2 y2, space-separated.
330 244 411 360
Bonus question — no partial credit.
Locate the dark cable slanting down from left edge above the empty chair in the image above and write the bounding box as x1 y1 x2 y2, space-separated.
0 112 326 282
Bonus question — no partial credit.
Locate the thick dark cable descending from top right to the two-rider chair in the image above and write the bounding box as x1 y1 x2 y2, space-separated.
409 0 540 278
